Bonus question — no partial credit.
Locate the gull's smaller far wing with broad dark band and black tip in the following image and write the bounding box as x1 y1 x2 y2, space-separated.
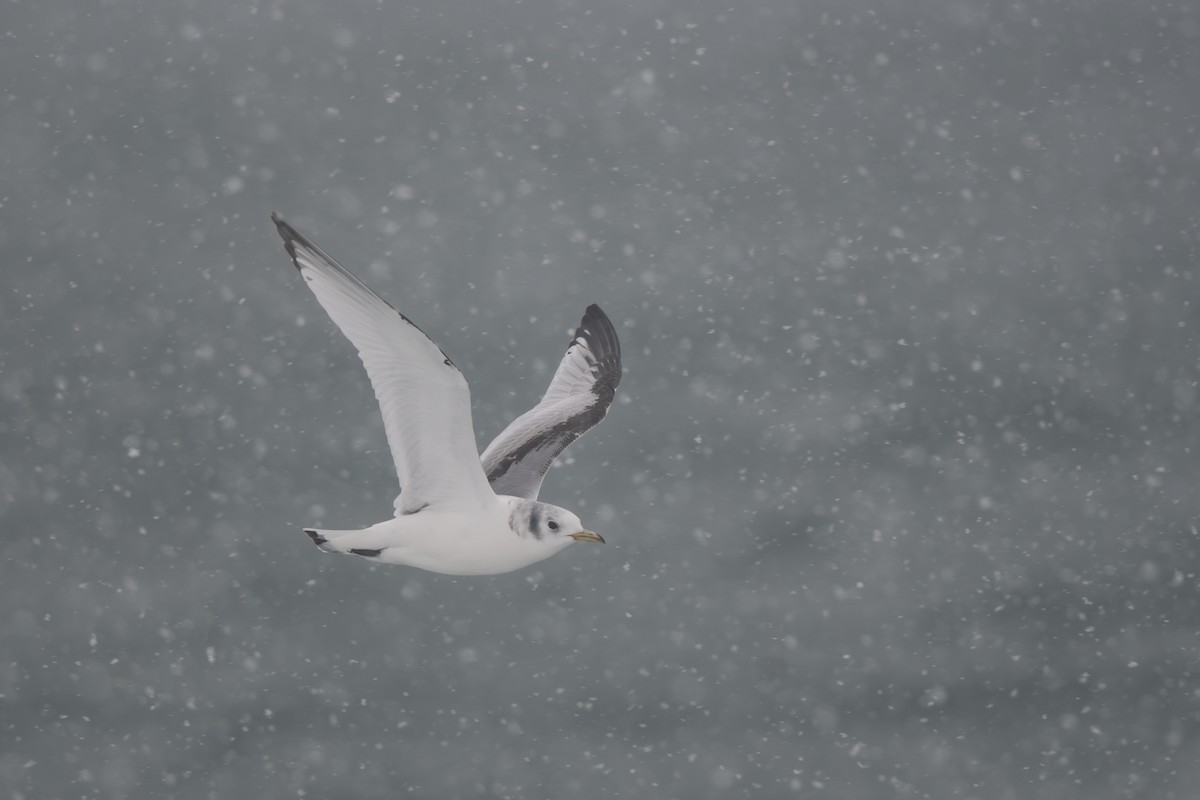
480 306 620 499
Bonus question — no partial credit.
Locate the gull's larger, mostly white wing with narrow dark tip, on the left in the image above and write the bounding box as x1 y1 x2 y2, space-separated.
271 213 494 516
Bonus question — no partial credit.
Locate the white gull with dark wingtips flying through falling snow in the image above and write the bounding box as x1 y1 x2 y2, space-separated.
271 213 620 575
